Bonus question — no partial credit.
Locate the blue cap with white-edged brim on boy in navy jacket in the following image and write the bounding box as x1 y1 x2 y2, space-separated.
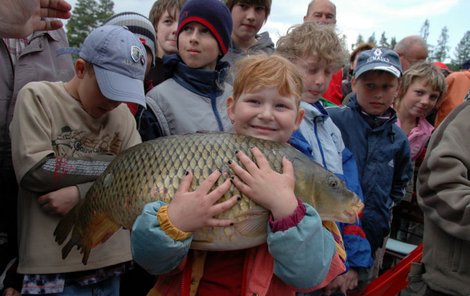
354 48 402 78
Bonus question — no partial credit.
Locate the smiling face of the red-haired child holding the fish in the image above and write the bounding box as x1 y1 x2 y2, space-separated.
227 86 304 143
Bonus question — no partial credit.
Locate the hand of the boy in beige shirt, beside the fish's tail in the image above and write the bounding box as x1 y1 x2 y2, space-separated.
38 186 80 215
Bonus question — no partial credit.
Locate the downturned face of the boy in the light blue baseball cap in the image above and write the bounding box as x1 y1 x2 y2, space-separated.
77 65 121 118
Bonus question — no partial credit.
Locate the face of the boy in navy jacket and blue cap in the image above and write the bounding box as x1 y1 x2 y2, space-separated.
351 70 399 115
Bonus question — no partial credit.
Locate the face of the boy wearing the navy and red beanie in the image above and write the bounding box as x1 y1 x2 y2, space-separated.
178 22 220 70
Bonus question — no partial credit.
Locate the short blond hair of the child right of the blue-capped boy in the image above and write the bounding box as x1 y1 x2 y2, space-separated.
395 62 447 109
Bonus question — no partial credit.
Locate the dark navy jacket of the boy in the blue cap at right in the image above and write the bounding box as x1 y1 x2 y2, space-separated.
328 95 412 254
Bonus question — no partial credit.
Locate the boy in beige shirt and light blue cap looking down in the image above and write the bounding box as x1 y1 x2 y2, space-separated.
10 26 146 295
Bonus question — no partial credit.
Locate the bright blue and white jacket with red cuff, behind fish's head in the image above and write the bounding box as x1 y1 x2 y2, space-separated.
289 102 372 268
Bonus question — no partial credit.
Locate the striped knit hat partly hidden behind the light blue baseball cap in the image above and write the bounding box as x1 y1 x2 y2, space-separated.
104 12 156 65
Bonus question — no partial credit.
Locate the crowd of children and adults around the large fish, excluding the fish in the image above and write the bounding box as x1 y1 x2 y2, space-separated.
0 0 470 296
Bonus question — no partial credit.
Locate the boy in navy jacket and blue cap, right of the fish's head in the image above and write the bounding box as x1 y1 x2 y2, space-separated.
328 48 412 278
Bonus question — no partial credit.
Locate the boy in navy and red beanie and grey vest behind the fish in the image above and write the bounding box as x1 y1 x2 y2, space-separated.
137 0 232 141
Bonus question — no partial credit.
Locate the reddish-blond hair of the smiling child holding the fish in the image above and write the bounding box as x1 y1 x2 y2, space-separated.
233 53 303 107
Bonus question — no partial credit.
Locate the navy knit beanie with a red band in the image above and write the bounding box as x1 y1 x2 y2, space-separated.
176 0 232 55
